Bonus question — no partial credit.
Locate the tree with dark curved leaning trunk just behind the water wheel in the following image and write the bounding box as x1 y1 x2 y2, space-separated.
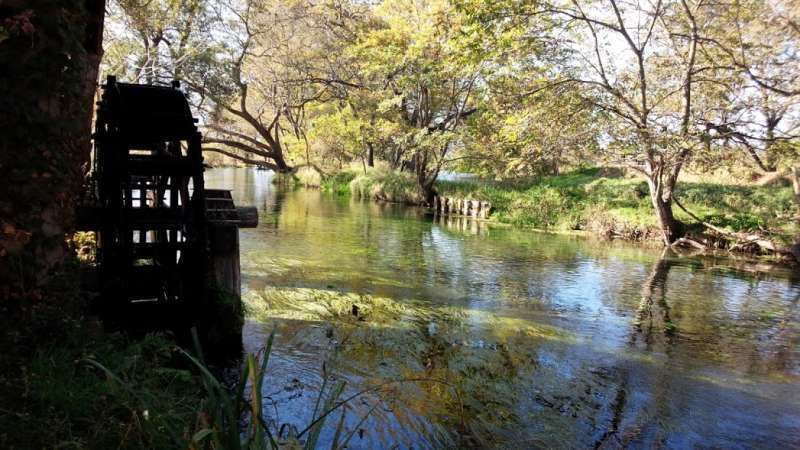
105 0 357 172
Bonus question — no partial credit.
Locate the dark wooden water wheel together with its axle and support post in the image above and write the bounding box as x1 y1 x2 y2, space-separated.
78 77 258 348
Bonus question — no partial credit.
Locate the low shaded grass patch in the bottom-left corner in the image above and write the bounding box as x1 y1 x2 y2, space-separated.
0 331 203 448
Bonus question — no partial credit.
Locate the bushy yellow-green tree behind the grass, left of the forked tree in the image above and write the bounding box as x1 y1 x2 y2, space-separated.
461 62 604 179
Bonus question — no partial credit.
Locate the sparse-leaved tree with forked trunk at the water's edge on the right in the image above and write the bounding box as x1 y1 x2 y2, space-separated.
468 0 800 245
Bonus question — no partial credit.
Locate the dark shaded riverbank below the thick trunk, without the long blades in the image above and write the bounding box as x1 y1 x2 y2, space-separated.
0 265 205 449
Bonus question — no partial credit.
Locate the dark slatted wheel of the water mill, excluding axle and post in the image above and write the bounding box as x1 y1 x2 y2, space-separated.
93 77 206 312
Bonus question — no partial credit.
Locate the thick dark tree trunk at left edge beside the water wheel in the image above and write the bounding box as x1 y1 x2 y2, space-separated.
0 0 105 300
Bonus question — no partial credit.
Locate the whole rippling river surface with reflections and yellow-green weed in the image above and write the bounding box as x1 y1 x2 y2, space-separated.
207 169 800 448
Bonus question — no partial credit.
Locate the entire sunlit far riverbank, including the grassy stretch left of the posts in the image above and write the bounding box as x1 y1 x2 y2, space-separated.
300 167 796 248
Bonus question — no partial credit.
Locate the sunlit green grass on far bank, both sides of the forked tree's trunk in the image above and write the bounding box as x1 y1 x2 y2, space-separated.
436 168 795 238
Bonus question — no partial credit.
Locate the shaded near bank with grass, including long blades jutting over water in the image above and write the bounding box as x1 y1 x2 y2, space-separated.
0 261 355 449
